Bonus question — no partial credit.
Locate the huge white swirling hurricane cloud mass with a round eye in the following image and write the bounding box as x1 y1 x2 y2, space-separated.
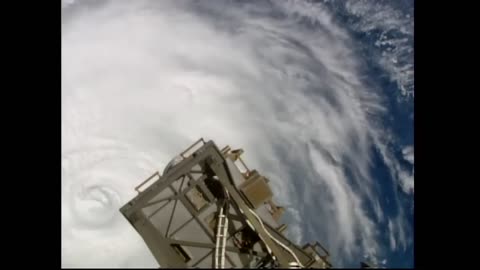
62 1 413 267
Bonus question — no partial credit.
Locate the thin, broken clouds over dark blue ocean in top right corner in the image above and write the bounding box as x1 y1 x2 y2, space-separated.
264 0 414 97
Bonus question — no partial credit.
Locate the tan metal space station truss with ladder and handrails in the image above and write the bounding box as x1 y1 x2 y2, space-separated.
120 139 331 268
